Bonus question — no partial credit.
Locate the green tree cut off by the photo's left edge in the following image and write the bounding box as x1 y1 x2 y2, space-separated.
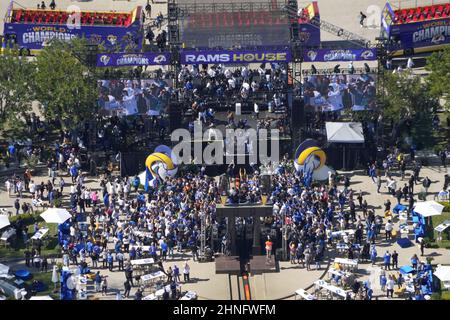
0 48 35 136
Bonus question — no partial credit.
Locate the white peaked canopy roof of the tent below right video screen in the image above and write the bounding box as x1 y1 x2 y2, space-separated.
325 122 364 143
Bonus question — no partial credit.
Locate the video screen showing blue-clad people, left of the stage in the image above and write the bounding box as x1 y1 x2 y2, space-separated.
97 79 172 116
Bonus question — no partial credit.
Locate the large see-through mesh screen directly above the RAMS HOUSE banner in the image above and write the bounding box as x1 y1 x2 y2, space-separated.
178 0 290 48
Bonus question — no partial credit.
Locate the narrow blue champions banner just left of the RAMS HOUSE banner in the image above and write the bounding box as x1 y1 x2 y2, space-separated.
97 53 170 67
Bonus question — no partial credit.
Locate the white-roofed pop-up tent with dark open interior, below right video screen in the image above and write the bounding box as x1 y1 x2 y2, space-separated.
325 122 365 169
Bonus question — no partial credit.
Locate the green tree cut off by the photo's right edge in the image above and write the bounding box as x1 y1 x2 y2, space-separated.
425 47 450 103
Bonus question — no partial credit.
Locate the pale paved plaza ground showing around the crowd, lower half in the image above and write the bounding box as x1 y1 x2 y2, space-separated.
0 162 450 300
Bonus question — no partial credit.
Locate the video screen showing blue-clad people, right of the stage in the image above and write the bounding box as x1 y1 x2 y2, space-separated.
303 74 376 112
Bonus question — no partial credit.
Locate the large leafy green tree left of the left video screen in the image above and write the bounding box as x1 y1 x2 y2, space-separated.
34 38 97 129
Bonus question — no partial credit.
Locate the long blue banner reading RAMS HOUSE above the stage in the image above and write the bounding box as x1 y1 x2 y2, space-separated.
180 49 292 64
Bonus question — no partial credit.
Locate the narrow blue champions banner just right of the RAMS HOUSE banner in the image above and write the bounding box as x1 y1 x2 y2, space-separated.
303 49 377 62
